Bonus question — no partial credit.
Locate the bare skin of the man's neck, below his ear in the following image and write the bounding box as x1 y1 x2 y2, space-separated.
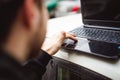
4 26 29 63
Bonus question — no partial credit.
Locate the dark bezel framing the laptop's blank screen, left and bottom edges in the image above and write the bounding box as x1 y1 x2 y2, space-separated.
80 0 120 30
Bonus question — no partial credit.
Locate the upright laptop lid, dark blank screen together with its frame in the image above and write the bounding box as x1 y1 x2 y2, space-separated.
81 0 120 27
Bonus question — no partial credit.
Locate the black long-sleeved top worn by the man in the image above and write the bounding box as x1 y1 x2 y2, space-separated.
0 50 52 80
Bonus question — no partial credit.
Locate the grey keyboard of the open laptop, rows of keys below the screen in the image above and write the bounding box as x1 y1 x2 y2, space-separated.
70 28 120 43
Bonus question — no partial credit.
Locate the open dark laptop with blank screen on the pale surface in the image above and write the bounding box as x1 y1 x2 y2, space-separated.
62 0 120 59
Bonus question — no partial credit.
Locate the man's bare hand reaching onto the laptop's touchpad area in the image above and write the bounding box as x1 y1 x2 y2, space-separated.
42 31 77 56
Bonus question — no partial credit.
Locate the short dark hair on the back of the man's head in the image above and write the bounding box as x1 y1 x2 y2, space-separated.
0 0 24 45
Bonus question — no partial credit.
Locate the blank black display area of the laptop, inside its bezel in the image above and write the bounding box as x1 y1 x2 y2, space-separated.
81 0 120 21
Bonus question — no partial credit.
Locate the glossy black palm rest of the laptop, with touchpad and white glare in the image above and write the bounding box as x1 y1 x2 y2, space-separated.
63 38 120 59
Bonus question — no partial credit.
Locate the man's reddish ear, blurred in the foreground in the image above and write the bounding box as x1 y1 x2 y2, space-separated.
23 0 35 28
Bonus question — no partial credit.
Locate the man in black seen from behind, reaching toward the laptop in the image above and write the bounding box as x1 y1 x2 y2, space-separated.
0 0 77 80
